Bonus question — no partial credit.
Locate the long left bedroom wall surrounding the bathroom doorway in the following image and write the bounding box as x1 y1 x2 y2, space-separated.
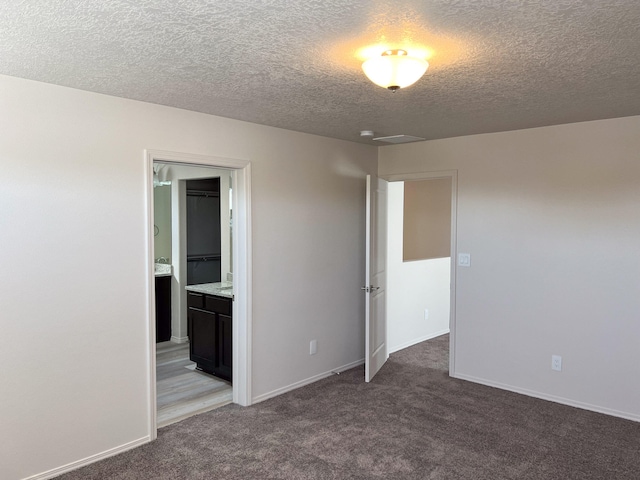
0 76 377 480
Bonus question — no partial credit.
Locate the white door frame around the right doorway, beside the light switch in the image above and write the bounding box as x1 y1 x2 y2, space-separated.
379 170 458 377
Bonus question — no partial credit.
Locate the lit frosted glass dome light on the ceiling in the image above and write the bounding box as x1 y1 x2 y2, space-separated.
362 50 429 92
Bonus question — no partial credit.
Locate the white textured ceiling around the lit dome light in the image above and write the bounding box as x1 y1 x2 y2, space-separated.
0 0 640 143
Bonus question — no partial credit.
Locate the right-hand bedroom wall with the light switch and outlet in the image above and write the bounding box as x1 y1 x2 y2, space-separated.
379 117 640 420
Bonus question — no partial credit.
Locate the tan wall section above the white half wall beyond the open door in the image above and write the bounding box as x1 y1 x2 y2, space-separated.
402 178 451 262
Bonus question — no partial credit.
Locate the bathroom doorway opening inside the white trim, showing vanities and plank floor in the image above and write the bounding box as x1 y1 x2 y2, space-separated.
153 162 233 427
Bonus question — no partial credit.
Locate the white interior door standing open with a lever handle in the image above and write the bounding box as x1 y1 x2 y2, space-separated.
363 175 388 382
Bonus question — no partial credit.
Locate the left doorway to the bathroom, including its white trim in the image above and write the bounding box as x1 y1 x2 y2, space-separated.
147 152 250 436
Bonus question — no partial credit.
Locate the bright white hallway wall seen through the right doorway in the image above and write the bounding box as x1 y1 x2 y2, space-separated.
387 182 451 353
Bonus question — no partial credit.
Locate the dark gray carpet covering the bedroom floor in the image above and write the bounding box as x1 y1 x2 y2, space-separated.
59 336 640 480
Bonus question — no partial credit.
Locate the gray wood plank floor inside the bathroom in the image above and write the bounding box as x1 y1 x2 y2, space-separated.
156 342 233 428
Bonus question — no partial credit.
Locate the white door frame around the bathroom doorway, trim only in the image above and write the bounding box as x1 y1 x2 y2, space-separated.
144 149 252 440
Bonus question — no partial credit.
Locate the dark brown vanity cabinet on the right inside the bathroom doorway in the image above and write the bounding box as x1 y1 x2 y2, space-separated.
187 292 233 381
